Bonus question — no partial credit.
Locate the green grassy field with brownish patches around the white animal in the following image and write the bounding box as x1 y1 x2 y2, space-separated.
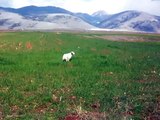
0 32 160 120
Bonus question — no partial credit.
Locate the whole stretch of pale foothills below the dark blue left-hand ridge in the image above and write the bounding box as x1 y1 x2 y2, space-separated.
0 11 94 30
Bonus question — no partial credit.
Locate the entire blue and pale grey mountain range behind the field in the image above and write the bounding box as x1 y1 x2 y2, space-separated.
0 6 160 33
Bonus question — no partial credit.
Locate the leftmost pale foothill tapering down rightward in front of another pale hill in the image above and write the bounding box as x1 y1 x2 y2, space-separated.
0 11 57 30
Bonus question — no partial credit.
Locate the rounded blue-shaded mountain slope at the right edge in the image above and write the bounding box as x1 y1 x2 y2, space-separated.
99 11 160 32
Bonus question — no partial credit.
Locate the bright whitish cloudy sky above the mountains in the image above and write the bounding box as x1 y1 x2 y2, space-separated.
0 0 160 16
